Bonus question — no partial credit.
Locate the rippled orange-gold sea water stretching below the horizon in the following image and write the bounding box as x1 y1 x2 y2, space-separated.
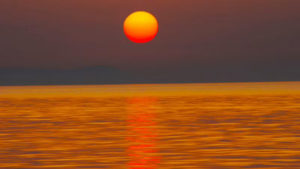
0 82 300 169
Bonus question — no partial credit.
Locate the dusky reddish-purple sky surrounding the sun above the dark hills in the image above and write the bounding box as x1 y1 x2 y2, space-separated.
0 0 300 81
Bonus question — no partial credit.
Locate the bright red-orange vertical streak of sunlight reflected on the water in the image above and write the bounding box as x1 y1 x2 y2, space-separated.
127 97 160 169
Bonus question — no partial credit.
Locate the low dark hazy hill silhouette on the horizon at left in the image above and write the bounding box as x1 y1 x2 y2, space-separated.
0 66 130 86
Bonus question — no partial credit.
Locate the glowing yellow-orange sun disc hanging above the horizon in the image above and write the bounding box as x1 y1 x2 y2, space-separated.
124 11 158 43
